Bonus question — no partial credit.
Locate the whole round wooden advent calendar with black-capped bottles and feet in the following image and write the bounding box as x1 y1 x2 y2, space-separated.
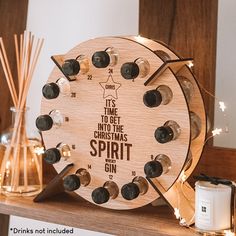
36 37 206 224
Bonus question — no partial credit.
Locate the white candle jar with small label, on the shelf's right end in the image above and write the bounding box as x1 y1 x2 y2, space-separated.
195 181 232 231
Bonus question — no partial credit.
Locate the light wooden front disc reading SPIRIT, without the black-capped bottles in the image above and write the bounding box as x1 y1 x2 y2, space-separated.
41 37 204 209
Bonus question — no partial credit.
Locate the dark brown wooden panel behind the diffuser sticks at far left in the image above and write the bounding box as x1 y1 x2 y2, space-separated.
0 0 28 132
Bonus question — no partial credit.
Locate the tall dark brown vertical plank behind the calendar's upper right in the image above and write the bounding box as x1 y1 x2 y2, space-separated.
139 0 217 123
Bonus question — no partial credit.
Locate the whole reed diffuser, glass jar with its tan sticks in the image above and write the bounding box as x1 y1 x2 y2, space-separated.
0 32 43 196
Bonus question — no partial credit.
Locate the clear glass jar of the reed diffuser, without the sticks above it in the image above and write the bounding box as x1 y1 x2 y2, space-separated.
0 107 44 196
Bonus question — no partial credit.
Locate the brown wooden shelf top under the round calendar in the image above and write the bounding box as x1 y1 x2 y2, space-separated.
0 193 198 236
